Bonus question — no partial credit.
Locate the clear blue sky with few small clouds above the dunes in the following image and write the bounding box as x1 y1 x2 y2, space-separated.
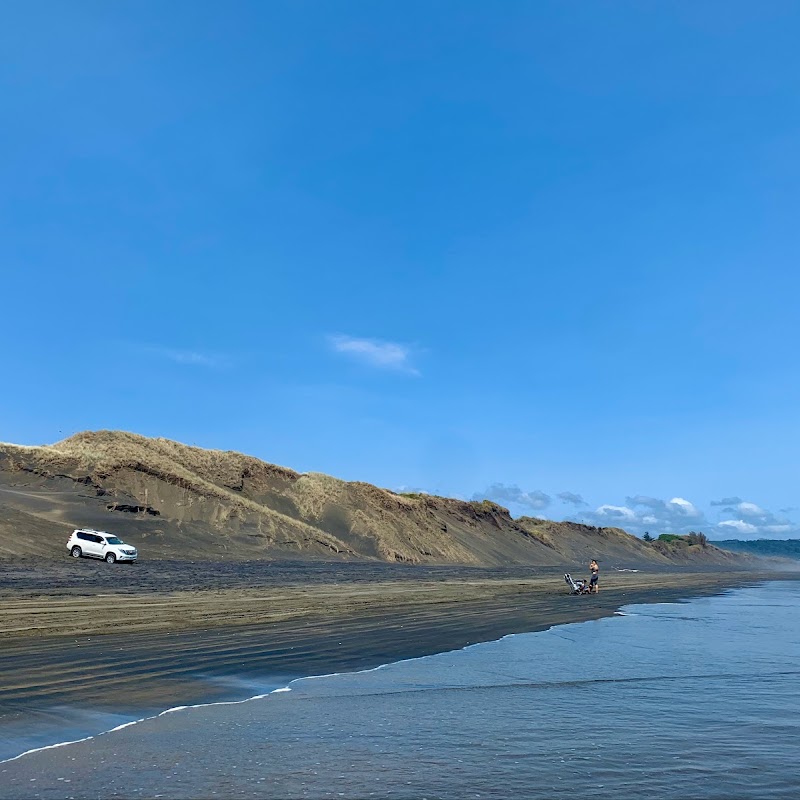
0 0 800 538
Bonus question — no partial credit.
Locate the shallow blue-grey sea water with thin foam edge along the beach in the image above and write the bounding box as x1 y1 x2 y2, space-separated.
0 581 800 800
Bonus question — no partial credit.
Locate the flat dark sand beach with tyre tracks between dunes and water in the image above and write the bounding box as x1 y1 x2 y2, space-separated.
0 561 776 758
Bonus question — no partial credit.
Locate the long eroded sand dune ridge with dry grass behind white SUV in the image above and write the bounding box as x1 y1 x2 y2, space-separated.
0 431 748 566
